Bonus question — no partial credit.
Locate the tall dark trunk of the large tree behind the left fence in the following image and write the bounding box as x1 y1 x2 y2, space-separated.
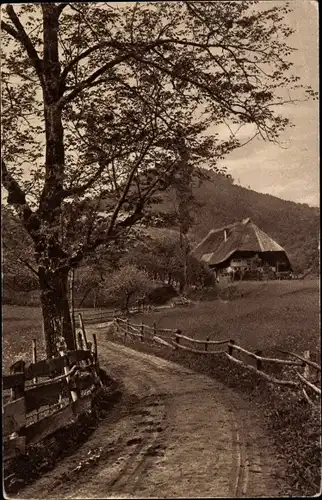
36 4 75 357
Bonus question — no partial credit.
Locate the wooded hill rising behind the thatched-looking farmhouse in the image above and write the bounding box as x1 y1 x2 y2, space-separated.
149 172 320 272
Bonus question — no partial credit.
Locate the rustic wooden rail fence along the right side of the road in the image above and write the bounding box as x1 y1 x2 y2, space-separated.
110 318 321 408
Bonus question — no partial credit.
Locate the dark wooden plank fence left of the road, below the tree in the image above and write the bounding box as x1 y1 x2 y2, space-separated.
2 329 102 460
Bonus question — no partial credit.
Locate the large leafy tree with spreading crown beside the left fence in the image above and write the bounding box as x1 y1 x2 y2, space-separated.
1 1 311 356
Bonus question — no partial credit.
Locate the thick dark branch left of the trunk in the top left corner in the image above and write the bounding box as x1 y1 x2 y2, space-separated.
1 5 44 85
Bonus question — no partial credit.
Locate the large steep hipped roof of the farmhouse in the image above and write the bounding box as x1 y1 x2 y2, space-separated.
192 219 286 265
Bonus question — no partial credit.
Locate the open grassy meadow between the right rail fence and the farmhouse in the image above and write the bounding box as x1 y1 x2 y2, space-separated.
127 280 321 357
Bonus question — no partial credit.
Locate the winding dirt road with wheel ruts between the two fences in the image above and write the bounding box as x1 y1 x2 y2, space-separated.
18 339 285 499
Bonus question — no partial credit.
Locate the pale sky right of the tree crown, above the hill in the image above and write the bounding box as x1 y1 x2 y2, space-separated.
215 0 320 206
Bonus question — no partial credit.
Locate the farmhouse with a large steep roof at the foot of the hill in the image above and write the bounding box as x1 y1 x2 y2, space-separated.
192 219 292 280
